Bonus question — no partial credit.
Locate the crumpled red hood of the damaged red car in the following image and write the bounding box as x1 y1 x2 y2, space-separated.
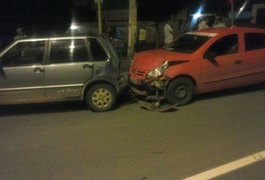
132 49 191 72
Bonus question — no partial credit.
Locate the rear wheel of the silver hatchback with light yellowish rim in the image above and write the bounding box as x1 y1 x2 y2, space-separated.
86 84 117 112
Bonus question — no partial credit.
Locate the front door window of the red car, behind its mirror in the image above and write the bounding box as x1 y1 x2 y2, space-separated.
206 34 238 56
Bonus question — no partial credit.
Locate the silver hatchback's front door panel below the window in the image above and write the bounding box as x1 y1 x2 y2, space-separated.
0 66 44 104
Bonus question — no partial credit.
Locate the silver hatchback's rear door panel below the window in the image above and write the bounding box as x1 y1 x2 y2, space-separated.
44 62 93 100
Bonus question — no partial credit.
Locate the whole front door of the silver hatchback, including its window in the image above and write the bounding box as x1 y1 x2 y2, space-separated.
0 40 45 104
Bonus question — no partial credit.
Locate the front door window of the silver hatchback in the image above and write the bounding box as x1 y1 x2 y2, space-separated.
1 41 45 67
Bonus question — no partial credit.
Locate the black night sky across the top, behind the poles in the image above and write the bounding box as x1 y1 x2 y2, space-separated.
0 0 264 33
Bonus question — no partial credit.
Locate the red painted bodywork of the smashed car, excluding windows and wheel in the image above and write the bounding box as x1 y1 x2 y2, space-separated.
129 27 265 100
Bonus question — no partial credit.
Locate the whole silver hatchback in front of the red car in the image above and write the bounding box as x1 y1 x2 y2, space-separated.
0 36 124 112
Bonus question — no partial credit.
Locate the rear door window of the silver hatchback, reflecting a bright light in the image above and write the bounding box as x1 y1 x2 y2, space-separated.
50 39 89 64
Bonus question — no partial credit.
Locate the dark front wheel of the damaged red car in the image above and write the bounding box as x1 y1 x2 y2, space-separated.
166 77 194 105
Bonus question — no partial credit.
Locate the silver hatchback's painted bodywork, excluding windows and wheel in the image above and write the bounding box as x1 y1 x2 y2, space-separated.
0 36 120 104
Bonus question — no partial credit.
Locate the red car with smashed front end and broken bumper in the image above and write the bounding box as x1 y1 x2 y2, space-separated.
129 27 265 105
